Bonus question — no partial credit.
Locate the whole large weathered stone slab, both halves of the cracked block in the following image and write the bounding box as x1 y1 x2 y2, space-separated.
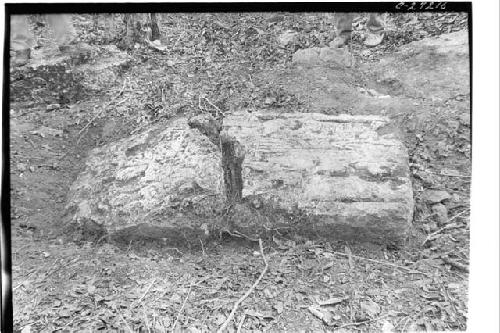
64 112 413 242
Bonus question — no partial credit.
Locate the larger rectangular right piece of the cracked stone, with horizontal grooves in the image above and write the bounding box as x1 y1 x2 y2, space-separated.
223 112 413 240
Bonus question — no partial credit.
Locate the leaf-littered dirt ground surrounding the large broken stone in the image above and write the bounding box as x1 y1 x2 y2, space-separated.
9 13 471 332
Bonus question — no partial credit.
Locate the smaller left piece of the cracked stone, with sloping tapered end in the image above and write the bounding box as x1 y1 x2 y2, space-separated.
67 118 225 237
